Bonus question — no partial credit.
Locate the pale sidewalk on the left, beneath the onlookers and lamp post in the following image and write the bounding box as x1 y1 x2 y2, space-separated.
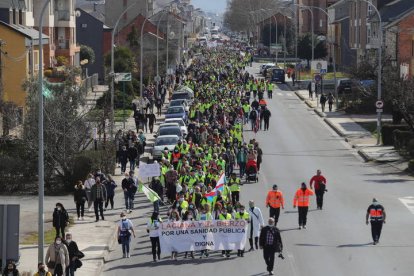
15 103 168 276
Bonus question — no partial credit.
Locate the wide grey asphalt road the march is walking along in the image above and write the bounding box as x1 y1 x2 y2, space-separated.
104 64 414 276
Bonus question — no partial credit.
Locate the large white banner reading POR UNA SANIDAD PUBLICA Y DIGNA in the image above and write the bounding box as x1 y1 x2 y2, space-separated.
158 220 248 255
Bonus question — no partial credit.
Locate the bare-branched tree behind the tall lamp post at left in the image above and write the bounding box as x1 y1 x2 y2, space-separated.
24 69 91 189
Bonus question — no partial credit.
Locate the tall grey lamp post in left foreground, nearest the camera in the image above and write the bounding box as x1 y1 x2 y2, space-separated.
37 0 50 262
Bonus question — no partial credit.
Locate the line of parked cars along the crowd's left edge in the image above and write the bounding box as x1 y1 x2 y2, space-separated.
152 86 194 160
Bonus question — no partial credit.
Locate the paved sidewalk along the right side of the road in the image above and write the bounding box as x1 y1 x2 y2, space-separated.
288 83 406 164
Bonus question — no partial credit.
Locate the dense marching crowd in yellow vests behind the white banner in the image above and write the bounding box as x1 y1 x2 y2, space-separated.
131 44 272 262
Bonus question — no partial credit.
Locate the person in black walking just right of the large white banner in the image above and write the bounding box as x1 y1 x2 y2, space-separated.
260 218 283 275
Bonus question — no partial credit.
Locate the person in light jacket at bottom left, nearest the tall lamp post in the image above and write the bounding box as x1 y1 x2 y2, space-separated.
45 237 70 276
